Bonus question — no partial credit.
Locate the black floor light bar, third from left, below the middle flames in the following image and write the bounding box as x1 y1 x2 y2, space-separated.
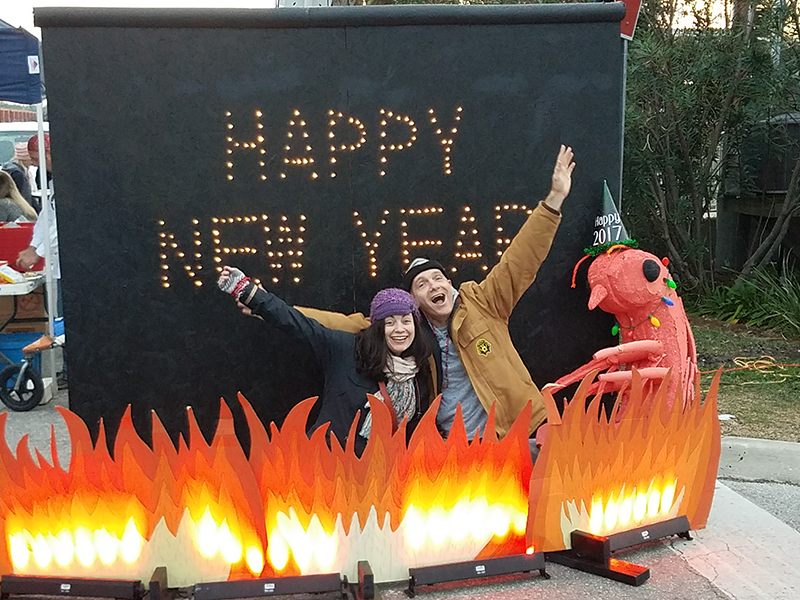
406 552 550 598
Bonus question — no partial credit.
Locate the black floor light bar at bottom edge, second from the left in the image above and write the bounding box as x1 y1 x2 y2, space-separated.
194 573 349 600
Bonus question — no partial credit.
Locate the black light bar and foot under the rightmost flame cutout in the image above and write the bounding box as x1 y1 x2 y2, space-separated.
547 516 692 586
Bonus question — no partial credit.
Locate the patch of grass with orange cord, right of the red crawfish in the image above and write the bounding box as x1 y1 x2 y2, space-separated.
689 315 800 442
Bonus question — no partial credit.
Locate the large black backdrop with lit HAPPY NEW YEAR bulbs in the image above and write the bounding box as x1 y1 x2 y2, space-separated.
36 4 624 444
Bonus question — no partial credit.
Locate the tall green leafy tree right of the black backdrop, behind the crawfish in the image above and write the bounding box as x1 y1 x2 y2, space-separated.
623 0 800 288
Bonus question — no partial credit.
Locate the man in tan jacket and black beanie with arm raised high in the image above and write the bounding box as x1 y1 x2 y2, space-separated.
301 145 575 438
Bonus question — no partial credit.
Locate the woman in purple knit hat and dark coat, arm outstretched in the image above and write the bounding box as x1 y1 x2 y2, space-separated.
218 267 433 455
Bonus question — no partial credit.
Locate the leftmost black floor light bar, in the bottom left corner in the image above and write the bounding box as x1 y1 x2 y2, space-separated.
0 575 144 600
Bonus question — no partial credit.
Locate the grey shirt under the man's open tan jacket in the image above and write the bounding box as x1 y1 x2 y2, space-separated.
433 327 489 439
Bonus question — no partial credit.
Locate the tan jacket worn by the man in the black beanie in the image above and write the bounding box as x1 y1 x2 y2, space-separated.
300 202 561 437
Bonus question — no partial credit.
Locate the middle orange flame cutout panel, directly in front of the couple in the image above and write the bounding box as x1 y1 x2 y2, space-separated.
240 396 531 580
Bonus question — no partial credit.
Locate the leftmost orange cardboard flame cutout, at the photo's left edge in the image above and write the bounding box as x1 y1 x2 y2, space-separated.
0 403 266 585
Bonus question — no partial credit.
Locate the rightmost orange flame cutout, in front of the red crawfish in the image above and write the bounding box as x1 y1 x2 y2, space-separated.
527 370 721 551
